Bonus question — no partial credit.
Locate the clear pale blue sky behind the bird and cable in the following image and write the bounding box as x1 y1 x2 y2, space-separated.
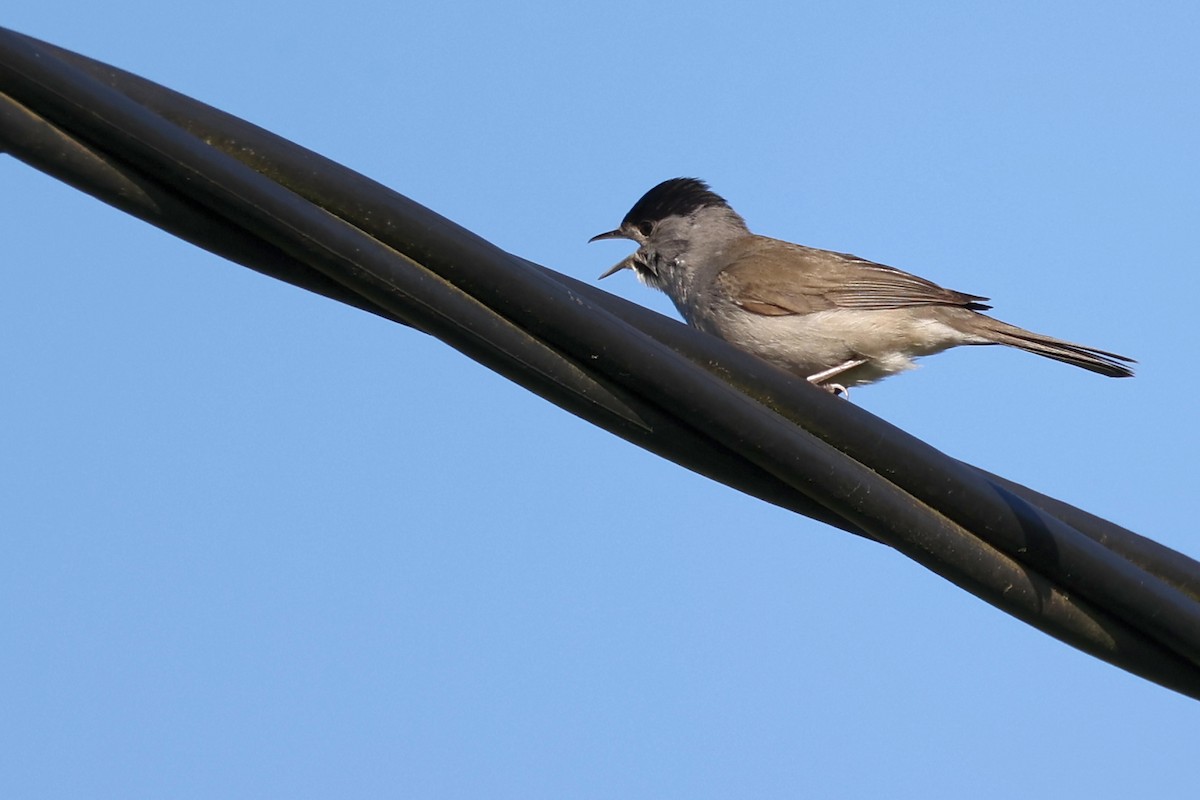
0 0 1200 798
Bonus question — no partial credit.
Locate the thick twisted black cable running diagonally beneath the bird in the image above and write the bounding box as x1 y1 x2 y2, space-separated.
0 30 1200 697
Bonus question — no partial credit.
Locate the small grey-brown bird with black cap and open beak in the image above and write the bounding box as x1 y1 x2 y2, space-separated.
589 178 1135 396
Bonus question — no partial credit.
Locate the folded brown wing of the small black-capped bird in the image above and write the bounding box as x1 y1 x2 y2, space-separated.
716 237 990 317
